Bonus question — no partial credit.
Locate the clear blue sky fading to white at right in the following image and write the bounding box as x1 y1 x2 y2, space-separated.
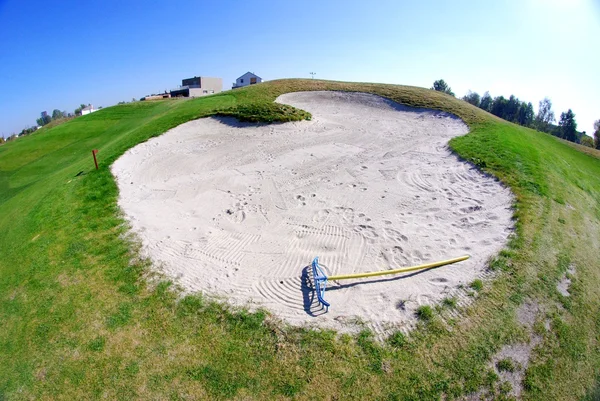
0 0 600 136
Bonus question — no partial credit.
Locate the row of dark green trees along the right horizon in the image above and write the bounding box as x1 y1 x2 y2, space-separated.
431 79 600 149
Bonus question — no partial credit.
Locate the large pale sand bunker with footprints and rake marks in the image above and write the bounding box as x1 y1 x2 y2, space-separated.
112 92 513 334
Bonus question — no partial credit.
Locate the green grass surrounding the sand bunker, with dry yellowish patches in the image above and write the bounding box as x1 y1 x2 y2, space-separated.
0 80 600 400
